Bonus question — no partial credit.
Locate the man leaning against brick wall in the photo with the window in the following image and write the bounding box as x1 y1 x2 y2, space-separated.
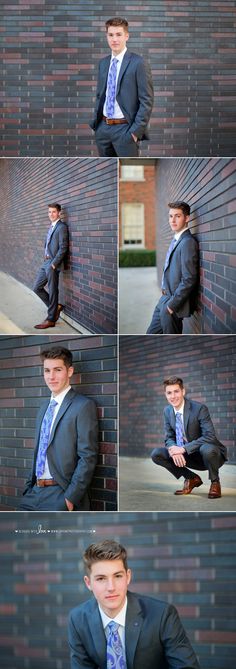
147 202 199 334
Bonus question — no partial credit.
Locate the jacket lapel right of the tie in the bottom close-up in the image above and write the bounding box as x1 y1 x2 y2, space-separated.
125 592 143 669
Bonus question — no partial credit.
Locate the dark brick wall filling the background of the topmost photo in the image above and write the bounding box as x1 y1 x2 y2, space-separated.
1 0 236 156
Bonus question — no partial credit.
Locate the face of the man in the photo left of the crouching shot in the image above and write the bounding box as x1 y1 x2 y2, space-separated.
43 358 74 397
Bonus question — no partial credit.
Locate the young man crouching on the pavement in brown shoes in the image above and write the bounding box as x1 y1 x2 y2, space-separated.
151 377 227 499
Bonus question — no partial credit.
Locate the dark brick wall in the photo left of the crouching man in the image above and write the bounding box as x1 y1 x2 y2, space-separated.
0 335 116 511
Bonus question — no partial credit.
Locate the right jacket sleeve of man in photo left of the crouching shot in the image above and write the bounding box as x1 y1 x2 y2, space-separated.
65 399 98 506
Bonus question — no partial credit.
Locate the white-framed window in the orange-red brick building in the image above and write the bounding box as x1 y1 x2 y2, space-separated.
121 202 145 249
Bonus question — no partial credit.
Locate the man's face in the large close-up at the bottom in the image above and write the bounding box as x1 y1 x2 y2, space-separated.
84 560 131 618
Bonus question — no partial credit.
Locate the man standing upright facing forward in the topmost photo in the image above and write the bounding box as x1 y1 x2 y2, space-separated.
90 17 153 157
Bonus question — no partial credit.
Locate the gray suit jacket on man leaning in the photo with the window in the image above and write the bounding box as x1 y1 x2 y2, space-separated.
163 230 199 318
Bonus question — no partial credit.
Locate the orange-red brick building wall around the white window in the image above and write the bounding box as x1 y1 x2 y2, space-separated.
119 161 156 251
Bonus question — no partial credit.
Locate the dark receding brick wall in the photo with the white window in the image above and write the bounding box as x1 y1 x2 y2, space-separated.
156 158 236 334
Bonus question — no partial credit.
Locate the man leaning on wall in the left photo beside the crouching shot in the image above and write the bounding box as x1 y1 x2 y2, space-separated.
19 347 98 511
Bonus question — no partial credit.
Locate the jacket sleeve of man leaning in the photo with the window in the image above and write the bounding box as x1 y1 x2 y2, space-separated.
167 237 199 311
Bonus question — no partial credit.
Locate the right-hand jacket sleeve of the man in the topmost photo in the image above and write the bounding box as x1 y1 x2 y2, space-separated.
129 59 154 139
